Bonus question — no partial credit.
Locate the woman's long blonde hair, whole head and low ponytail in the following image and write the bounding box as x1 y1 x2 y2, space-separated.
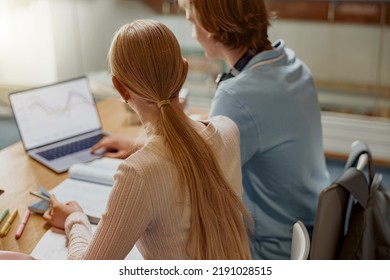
108 20 251 259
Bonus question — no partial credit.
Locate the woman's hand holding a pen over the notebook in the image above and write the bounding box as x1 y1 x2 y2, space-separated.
43 194 83 229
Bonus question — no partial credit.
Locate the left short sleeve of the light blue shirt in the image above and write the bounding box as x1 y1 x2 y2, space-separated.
210 90 261 165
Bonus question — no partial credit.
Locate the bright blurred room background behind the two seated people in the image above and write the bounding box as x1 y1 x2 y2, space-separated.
0 0 390 184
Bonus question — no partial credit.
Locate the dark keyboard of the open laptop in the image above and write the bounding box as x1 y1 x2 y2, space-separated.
38 135 102 160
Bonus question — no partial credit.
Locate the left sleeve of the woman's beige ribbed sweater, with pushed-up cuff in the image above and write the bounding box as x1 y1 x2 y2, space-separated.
65 164 153 260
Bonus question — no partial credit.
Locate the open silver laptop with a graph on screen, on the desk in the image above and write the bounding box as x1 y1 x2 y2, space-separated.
9 77 105 173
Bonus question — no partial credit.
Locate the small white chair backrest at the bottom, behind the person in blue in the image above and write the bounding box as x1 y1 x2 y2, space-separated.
290 221 310 260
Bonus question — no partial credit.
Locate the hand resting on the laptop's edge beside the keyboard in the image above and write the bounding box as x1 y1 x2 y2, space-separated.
90 135 145 159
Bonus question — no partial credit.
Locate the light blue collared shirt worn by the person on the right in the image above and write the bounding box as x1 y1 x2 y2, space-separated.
210 40 329 259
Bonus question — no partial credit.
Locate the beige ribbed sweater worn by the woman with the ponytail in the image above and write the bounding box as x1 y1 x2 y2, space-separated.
65 116 242 259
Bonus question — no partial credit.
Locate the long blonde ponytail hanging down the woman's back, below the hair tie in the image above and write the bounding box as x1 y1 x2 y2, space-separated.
161 106 250 259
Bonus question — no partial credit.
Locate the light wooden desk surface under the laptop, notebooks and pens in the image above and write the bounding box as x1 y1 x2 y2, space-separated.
0 99 143 254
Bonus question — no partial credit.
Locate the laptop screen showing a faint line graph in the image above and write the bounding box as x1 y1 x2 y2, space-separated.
9 77 101 150
